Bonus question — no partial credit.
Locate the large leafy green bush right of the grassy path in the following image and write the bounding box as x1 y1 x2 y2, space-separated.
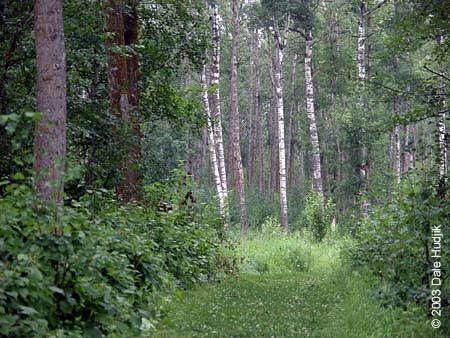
348 174 450 320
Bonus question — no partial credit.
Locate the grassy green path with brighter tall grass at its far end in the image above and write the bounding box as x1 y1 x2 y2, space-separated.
152 231 444 338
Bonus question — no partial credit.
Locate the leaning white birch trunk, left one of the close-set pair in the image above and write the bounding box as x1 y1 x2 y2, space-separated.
201 66 228 219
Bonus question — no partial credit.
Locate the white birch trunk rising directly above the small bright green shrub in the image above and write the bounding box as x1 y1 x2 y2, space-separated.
305 30 323 194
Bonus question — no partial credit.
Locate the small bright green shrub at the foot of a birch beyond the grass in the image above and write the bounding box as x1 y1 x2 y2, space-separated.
302 191 334 242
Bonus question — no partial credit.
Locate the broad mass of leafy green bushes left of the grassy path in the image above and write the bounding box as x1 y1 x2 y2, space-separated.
0 173 225 337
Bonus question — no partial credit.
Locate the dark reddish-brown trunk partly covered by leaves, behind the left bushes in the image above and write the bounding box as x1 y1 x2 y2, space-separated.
105 0 140 203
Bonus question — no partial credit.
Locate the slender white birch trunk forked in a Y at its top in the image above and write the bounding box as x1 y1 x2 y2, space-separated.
275 17 289 230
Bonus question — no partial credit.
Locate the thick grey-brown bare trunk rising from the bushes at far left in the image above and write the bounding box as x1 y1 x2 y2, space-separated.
33 0 66 205
